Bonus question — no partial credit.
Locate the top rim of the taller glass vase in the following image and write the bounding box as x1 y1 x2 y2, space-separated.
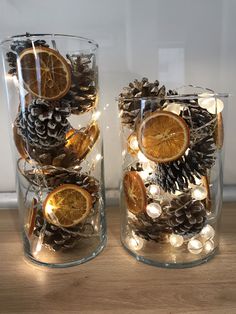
0 33 99 48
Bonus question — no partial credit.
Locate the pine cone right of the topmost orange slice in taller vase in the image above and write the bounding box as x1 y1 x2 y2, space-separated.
63 54 98 114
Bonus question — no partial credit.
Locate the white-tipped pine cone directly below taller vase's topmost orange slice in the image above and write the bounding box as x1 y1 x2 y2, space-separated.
16 99 70 149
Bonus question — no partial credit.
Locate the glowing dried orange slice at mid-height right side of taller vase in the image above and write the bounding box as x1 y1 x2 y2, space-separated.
66 122 100 160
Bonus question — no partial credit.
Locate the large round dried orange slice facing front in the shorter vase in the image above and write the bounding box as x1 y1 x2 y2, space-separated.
138 111 189 163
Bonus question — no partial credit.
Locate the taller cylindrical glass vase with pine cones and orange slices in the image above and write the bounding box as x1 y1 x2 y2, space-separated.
1 34 106 267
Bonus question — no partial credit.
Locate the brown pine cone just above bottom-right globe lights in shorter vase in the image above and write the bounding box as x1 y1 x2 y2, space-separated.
163 194 206 236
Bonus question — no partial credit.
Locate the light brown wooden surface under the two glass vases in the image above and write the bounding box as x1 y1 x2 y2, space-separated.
0 204 236 314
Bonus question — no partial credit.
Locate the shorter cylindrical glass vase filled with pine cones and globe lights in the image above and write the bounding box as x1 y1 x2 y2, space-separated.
119 79 228 268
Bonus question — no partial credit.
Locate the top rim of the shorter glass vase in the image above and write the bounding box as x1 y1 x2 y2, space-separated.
115 93 230 101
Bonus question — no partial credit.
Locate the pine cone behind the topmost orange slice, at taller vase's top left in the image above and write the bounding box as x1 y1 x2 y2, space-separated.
6 33 49 74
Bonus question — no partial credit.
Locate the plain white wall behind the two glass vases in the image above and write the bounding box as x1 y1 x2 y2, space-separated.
0 0 236 191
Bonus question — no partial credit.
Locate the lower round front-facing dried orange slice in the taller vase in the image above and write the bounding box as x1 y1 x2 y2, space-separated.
43 184 92 227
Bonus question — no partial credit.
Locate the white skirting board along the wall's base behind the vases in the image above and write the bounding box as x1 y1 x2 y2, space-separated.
0 185 236 209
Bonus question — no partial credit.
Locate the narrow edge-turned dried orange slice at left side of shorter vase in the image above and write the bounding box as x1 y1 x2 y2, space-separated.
123 171 147 215
